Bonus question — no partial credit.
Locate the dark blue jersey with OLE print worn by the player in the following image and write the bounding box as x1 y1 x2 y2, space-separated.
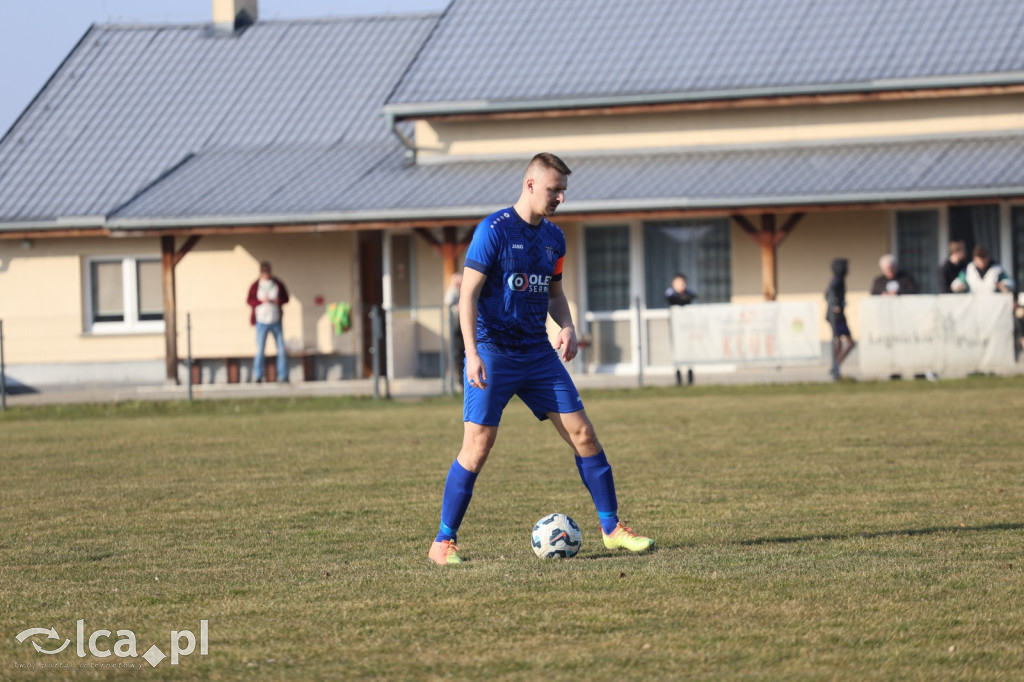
466 208 565 354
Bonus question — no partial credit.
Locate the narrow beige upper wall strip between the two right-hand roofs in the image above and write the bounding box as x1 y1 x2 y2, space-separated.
416 94 1024 160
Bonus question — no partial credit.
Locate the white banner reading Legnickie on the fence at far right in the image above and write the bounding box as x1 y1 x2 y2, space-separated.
857 294 1014 376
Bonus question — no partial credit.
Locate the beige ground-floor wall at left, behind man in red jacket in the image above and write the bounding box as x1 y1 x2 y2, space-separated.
0 229 356 365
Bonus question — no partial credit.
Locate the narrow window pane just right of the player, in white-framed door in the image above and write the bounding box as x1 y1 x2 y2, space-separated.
584 225 630 311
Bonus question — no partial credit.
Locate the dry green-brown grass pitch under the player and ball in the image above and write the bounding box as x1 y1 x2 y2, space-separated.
0 378 1024 680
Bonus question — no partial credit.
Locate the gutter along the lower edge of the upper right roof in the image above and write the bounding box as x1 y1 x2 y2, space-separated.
384 72 1024 120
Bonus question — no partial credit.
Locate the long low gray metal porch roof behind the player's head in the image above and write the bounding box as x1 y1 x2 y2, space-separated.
101 134 1024 229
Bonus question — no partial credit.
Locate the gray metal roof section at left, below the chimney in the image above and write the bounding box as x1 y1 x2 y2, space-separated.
0 14 437 223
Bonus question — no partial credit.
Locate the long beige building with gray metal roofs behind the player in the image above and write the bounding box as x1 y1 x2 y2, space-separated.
0 0 1024 385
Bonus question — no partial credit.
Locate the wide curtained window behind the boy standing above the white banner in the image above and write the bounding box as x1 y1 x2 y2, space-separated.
643 218 732 308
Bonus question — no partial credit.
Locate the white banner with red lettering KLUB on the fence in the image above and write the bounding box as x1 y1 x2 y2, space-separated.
669 302 821 366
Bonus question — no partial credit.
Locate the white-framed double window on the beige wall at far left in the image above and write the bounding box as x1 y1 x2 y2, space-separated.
85 257 164 334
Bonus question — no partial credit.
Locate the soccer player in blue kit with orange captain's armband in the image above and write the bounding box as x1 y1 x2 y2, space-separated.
429 154 654 565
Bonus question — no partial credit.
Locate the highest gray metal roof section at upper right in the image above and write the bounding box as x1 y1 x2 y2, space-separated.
387 0 1024 117
